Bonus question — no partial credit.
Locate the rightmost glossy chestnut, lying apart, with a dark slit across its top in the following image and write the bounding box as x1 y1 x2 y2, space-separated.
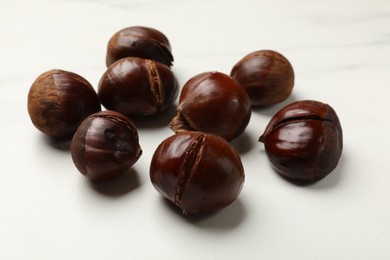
260 100 343 183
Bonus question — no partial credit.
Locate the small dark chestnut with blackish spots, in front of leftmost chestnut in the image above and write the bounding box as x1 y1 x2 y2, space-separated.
71 111 142 180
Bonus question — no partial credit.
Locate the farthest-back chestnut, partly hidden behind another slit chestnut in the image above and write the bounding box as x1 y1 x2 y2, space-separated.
106 26 173 67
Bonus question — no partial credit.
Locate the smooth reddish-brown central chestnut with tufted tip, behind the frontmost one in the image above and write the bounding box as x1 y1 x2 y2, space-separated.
170 72 252 141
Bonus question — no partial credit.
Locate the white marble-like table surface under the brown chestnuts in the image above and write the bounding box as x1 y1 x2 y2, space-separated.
0 0 390 260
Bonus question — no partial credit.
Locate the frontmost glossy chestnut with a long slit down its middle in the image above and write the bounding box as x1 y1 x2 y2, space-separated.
150 132 245 214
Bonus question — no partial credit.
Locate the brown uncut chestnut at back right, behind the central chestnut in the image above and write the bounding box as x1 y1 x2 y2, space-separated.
230 50 294 106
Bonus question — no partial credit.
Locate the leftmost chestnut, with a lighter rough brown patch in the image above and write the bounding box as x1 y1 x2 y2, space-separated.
28 69 101 138
